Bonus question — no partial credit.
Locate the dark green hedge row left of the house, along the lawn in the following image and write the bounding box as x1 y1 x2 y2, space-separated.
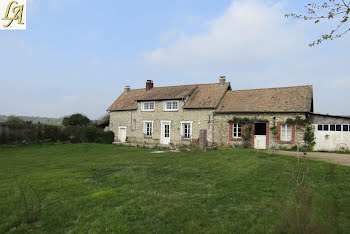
0 122 114 144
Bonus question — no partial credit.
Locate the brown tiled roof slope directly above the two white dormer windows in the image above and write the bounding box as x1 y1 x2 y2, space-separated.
137 85 198 101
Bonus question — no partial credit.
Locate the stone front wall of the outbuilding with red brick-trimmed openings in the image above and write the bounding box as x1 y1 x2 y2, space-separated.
214 113 305 148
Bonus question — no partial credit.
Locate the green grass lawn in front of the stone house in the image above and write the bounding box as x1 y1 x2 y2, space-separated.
0 144 350 233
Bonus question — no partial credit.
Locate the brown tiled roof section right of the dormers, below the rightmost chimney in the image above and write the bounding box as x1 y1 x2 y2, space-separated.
184 83 230 109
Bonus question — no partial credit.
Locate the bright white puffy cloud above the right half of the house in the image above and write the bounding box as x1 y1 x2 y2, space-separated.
144 1 304 68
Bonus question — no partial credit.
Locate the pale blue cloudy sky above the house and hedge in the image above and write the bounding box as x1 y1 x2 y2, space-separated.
0 0 350 119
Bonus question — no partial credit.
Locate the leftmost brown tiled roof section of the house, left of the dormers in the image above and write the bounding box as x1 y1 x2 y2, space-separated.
107 89 146 111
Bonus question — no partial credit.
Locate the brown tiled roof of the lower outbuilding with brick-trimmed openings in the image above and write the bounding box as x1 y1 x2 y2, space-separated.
217 85 313 113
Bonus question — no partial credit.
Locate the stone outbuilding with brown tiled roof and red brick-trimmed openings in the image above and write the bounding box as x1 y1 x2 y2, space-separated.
215 85 313 149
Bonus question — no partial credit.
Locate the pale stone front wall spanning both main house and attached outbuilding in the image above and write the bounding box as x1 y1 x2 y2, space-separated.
109 105 305 148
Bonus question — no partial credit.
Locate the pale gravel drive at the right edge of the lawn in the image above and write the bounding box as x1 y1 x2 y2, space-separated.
276 151 350 166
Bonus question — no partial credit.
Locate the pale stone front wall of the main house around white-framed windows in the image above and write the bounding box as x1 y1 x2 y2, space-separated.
110 101 213 145
